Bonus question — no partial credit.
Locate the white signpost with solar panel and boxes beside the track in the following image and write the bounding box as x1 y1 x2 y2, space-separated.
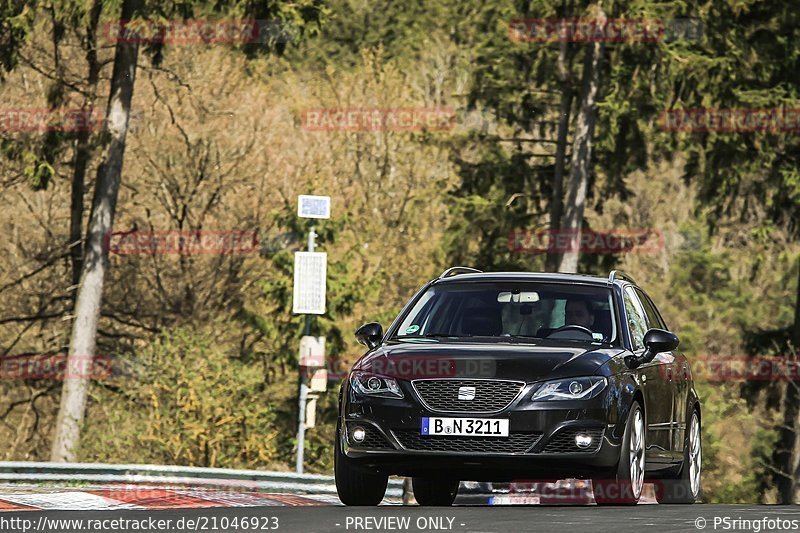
292 194 331 474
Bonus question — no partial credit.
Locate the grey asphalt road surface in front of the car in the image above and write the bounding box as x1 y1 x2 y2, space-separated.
0 505 800 533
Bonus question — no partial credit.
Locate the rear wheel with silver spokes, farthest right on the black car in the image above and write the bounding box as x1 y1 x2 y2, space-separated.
656 411 703 504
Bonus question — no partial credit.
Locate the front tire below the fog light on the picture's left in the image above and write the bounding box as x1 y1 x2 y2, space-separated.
333 427 389 506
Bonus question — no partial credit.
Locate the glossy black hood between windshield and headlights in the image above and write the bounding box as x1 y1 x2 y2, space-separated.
354 341 623 382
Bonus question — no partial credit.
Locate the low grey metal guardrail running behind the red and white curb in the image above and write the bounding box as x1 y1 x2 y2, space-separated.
0 461 403 498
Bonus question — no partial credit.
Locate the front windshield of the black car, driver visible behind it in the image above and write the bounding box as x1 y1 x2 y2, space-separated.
393 282 617 344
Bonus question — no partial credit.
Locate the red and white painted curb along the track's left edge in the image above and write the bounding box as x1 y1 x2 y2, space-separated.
0 486 341 512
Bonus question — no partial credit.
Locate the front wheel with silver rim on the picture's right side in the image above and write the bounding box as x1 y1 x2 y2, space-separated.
592 401 647 505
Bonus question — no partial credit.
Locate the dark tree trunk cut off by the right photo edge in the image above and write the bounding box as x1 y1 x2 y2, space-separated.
777 258 800 504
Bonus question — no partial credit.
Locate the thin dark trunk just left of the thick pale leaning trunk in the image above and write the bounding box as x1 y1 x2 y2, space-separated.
69 0 102 294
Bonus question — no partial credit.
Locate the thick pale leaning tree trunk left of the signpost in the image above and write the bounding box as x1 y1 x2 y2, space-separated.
51 0 141 462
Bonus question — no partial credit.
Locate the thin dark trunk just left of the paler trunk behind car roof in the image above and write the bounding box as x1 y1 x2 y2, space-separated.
546 40 573 272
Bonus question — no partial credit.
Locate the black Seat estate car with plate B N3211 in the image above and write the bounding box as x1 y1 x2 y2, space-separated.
335 267 701 505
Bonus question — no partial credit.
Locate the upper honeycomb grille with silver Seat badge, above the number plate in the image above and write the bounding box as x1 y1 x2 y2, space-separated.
412 379 525 413
